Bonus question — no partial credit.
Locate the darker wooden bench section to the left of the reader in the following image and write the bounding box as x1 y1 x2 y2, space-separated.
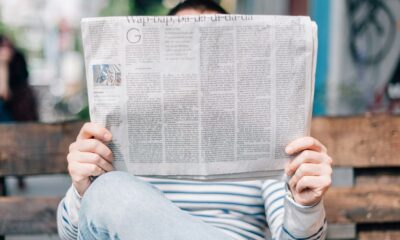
0 122 83 236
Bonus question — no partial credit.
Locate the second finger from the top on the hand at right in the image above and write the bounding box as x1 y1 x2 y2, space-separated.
285 150 332 176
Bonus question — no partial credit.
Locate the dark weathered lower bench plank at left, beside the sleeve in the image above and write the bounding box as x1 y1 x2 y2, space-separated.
0 197 61 235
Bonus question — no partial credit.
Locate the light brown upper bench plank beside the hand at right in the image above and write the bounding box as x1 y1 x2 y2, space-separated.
311 115 400 168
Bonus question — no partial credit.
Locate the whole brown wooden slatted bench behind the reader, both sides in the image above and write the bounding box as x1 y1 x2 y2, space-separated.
0 115 400 239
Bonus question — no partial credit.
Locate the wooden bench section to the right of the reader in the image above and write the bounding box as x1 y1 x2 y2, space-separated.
311 115 400 240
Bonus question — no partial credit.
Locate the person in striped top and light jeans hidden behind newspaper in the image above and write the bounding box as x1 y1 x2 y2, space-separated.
57 0 332 240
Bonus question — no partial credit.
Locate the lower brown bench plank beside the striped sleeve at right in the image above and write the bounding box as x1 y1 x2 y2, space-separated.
324 184 400 224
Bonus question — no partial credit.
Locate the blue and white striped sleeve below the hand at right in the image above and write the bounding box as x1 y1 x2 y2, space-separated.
262 180 327 240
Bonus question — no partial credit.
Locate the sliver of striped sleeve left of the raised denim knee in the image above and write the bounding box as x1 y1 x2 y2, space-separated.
57 186 81 240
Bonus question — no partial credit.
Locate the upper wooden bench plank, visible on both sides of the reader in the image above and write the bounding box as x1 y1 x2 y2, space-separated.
0 115 400 176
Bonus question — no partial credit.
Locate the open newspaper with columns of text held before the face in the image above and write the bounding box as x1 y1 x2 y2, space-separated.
82 15 317 180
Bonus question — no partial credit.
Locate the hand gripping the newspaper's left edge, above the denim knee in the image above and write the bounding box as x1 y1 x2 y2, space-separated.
67 123 113 196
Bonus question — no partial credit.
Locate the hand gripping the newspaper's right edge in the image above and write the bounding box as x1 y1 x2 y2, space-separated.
285 137 332 206
